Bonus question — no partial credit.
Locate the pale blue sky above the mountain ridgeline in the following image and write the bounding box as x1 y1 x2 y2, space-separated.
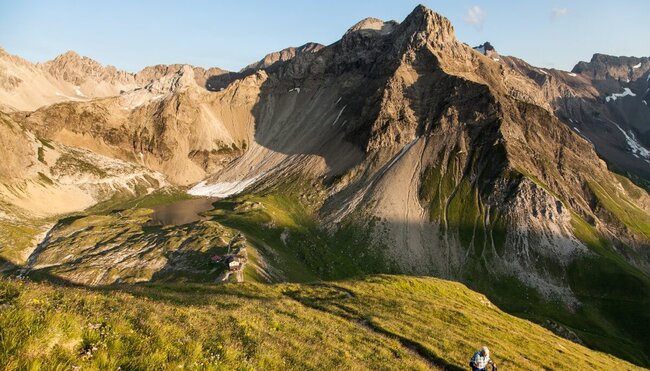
0 0 650 72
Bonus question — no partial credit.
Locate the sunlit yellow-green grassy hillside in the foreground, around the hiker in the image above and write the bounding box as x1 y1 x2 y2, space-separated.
0 276 634 370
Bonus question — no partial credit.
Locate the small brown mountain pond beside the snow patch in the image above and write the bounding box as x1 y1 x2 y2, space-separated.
151 197 218 225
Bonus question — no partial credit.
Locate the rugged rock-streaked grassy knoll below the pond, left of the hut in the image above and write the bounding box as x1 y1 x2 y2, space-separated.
30 208 234 285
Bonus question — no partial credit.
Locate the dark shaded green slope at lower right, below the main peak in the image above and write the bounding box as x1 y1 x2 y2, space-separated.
466 206 650 365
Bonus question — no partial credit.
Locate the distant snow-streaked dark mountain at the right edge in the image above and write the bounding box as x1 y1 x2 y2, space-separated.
502 54 650 189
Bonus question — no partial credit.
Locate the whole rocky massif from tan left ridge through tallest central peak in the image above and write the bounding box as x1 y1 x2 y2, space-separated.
16 7 650 286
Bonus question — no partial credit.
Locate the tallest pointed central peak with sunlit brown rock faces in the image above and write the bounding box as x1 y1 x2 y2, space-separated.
225 7 650 305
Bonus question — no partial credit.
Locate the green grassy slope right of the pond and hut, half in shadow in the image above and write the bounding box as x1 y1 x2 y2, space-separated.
206 190 391 282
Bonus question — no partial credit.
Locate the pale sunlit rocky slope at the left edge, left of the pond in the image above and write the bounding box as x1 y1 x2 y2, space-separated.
0 114 168 220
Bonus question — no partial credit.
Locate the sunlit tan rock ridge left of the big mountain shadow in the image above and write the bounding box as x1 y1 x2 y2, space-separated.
21 65 254 185
